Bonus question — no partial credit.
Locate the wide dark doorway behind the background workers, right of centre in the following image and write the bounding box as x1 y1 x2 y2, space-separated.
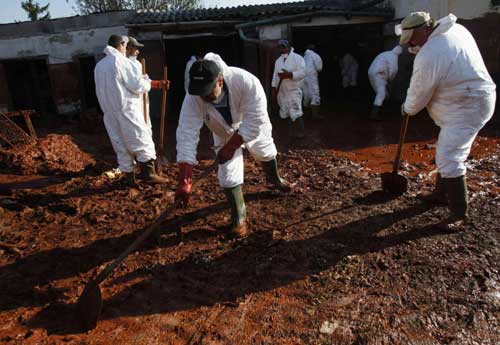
292 23 384 101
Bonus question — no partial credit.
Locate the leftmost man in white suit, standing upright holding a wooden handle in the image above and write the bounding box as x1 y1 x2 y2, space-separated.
94 35 167 186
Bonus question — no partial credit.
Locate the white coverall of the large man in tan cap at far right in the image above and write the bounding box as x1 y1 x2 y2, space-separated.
404 14 496 178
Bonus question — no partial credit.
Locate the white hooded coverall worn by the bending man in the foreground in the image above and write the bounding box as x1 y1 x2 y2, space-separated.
176 53 277 188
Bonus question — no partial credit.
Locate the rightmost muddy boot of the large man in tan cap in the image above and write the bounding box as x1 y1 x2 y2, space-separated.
443 176 469 230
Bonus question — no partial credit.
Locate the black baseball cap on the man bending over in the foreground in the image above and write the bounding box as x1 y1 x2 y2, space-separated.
188 59 222 96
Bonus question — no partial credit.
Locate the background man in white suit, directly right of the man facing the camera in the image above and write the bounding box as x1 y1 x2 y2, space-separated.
302 44 323 120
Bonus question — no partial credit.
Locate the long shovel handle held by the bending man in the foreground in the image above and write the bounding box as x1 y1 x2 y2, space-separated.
94 160 219 285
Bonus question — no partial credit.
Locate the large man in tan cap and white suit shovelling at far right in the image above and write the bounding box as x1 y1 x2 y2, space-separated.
400 12 496 229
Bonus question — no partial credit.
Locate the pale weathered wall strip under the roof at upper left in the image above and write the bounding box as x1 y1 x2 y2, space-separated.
0 26 128 64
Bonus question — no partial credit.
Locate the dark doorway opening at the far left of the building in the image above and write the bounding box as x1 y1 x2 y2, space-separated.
3 59 56 114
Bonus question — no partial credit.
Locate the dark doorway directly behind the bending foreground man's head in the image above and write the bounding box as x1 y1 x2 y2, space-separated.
164 35 242 116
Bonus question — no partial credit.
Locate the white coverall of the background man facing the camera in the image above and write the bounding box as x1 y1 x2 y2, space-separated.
271 48 306 121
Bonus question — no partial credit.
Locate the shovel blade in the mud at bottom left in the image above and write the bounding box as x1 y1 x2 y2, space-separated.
76 280 102 331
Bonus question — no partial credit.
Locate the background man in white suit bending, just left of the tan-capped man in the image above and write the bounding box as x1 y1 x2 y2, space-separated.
368 45 403 120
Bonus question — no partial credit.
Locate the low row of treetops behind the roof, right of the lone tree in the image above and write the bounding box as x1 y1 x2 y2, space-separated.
71 0 200 14
